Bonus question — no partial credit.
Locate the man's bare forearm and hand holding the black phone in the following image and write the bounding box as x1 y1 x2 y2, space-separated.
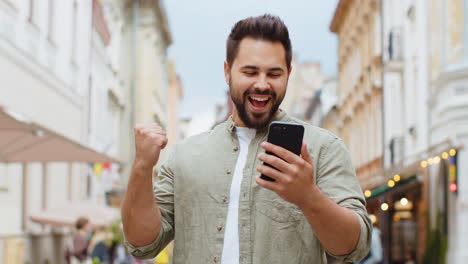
257 142 360 256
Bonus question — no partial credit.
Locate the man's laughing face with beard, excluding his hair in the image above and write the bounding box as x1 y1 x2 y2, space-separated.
224 38 290 128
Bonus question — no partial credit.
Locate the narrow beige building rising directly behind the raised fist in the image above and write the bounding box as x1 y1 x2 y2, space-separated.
132 1 172 129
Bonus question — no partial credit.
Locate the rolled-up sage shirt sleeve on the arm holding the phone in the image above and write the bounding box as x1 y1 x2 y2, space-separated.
316 138 372 262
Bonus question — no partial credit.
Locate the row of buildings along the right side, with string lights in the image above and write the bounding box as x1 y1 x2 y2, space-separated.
331 0 468 263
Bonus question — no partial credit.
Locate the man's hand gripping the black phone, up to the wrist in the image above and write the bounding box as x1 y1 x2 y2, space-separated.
257 142 316 207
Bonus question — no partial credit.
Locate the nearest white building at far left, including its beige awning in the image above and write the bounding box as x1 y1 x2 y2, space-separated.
0 0 119 264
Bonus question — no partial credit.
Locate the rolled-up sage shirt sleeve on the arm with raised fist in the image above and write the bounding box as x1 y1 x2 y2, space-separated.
124 148 175 259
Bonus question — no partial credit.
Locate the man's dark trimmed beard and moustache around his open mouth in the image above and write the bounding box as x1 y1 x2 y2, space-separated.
229 77 284 129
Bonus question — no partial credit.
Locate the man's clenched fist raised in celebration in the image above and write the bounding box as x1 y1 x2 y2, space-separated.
134 123 167 168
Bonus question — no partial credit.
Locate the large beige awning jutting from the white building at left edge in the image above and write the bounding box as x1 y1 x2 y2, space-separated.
0 106 119 163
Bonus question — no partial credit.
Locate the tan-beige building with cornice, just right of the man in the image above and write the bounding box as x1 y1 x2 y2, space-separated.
330 0 383 188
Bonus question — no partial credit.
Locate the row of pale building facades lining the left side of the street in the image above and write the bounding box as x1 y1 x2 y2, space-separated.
0 0 177 263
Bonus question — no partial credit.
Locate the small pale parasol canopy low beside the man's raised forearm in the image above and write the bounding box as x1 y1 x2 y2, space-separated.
31 201 120 228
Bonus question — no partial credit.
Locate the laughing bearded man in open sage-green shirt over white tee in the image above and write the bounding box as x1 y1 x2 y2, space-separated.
122 15 371 264
